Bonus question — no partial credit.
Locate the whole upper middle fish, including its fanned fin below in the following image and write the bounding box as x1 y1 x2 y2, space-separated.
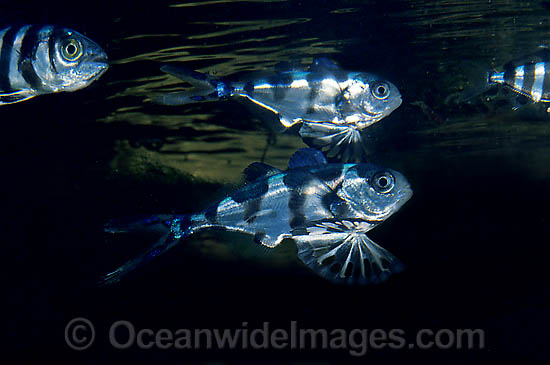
154 58 402 162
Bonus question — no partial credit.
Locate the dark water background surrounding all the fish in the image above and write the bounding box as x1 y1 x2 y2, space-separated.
4 0 550 363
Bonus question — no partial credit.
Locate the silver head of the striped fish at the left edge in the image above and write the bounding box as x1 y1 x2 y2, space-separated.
35 28 109 92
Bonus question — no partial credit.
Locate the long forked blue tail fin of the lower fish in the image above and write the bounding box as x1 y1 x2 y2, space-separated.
99 216 191 285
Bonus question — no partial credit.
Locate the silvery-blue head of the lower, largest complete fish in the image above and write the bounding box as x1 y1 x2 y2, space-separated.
337 164 413 222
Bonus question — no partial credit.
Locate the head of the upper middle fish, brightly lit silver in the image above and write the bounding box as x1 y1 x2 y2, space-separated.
344 72 402 126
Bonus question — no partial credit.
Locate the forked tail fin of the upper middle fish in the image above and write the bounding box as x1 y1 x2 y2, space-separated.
154 65 231 105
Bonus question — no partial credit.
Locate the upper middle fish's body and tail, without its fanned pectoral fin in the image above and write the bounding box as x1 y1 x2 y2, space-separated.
158 59 401 128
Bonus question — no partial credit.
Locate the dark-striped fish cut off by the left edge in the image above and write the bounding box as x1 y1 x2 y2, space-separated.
0 25 109 105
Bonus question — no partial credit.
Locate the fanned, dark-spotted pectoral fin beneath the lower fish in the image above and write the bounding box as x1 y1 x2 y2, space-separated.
293 219 403 285
